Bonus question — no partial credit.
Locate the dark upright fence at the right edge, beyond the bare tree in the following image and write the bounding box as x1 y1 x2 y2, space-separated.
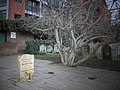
96 42 120 61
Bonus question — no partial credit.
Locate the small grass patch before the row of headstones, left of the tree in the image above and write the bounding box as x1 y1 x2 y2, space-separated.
35 53 61 62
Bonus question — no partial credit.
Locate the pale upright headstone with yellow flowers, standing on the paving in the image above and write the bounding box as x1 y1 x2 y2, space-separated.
18 54 34 82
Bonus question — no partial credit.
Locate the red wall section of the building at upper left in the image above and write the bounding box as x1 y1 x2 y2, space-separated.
8 0 26 20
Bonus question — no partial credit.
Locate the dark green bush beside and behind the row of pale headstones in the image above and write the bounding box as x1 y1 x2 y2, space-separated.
25 40 54 54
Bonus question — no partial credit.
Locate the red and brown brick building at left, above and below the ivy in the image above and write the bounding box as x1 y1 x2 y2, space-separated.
0 0 40 55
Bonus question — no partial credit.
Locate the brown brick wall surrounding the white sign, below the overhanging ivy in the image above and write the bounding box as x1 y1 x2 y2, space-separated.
0 32 34 56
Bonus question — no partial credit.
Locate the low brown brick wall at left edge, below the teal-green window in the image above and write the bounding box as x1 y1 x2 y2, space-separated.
0 43 18 56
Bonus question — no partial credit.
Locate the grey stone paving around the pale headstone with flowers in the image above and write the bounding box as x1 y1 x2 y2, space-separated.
0 55 120 90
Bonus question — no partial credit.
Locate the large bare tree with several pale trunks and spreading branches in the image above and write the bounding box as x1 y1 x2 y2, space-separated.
23 0 118 66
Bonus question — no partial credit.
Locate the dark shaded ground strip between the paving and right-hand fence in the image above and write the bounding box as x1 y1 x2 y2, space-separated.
80 58 120 72
